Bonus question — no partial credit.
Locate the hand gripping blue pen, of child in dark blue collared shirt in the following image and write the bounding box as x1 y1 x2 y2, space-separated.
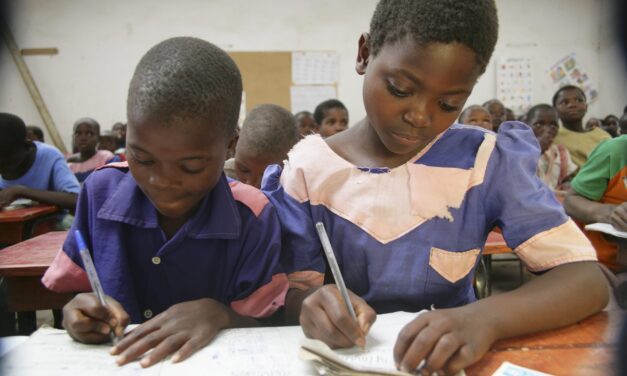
63 293 130 343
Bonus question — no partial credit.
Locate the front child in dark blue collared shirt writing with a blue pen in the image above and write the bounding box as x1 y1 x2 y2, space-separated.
43 38 287 367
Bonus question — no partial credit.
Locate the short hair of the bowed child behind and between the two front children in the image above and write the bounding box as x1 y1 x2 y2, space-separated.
238 104 299 157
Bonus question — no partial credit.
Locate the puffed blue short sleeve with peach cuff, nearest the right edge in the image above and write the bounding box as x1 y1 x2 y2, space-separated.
484 122 596 271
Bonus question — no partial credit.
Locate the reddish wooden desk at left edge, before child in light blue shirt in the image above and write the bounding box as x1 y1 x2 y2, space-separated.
0 204 61 245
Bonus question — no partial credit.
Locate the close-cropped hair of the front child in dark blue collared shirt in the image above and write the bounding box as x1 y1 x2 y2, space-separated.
126 37 242 137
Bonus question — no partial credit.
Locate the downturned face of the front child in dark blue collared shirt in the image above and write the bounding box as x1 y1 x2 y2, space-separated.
126 119 230 221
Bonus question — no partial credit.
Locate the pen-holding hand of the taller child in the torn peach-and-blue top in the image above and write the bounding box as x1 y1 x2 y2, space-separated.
299 285 377 348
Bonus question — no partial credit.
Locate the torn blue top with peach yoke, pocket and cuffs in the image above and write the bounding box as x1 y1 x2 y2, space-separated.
262 122 596 313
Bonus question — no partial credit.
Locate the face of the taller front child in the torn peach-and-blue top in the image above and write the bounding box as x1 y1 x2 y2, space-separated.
357 37 480 156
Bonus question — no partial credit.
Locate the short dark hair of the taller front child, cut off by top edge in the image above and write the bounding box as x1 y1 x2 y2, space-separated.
369 0 499 73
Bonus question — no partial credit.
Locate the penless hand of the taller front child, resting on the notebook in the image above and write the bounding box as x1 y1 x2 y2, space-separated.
394 307 496 375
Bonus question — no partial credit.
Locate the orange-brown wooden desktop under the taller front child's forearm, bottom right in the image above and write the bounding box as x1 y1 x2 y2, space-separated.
466 310 626 376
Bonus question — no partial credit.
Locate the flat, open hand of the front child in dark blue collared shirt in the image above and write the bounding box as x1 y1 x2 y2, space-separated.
111 298 231 367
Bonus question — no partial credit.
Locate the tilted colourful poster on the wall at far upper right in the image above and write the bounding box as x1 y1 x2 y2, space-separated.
549 52 599 103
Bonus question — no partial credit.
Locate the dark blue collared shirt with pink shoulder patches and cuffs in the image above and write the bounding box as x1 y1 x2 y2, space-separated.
42 163 288 323
